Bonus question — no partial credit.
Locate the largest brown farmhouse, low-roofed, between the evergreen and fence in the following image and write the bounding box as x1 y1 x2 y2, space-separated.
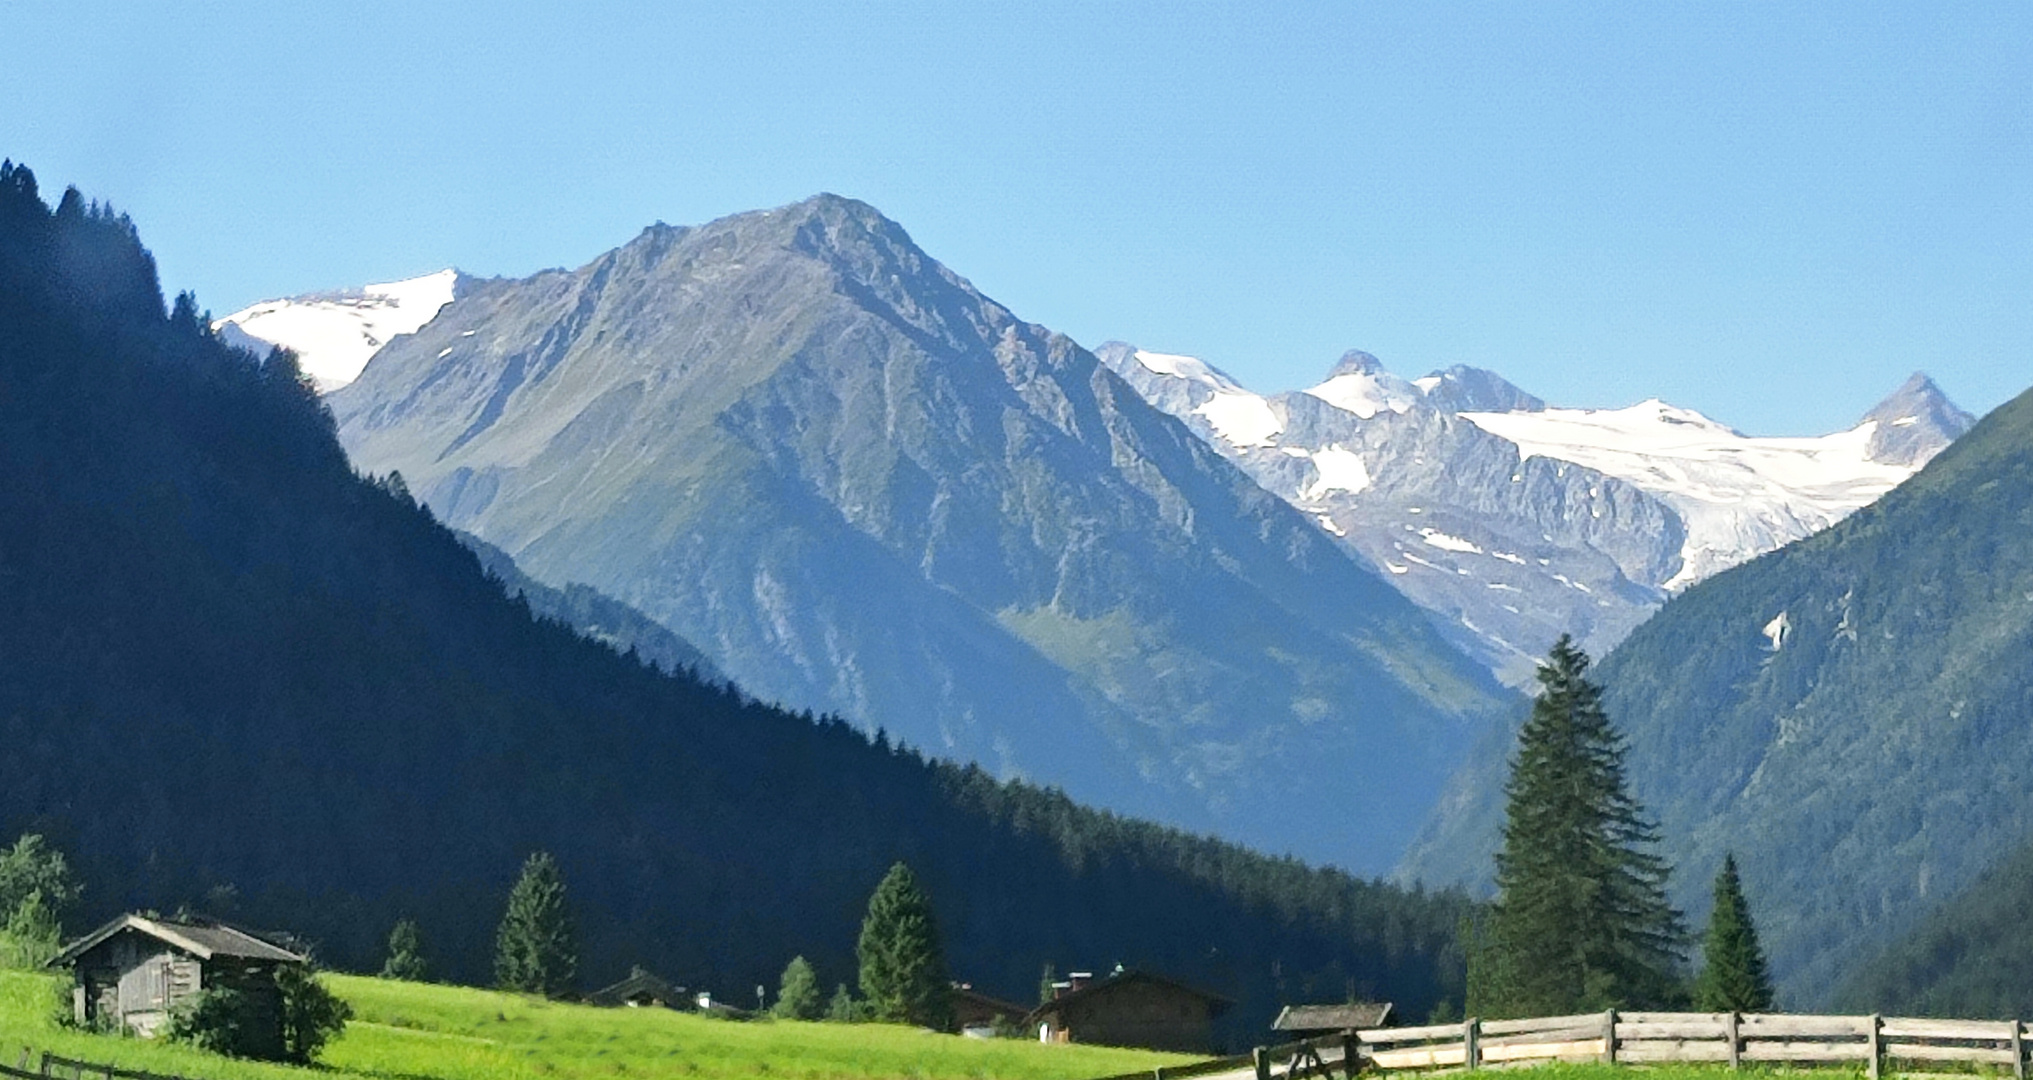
1029 970 1234 1054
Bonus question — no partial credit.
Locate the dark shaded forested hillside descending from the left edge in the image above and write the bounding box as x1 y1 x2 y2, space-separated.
0 167 1464 1035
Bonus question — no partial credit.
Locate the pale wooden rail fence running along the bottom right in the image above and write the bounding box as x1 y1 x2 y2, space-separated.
1105 1009 2033 1080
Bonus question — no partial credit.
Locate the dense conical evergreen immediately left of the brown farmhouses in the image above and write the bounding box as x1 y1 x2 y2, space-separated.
856 862 951 1029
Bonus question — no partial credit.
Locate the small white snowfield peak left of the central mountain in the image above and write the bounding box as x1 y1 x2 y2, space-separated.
211 271 459 393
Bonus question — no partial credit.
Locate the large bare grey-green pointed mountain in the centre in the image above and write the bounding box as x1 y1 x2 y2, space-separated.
327 197 1506 868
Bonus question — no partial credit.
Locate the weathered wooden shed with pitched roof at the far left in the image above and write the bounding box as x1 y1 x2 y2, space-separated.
49 915 305 1047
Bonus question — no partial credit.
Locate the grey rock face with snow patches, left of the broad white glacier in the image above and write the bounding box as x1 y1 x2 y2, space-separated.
1096 342 1683 683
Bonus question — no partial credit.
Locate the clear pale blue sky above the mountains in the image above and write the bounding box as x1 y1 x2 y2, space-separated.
0 0 2033 433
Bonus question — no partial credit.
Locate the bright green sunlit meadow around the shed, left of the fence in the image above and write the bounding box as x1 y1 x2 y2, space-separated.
0 972 1187 1080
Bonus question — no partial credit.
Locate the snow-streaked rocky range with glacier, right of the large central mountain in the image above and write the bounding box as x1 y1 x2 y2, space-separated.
1096 342 1970 685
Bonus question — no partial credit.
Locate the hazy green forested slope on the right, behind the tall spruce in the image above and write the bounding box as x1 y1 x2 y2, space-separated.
1407 380 2033 1009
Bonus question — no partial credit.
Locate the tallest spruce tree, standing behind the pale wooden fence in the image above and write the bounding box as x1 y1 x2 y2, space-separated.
1470 635 1685 1017
